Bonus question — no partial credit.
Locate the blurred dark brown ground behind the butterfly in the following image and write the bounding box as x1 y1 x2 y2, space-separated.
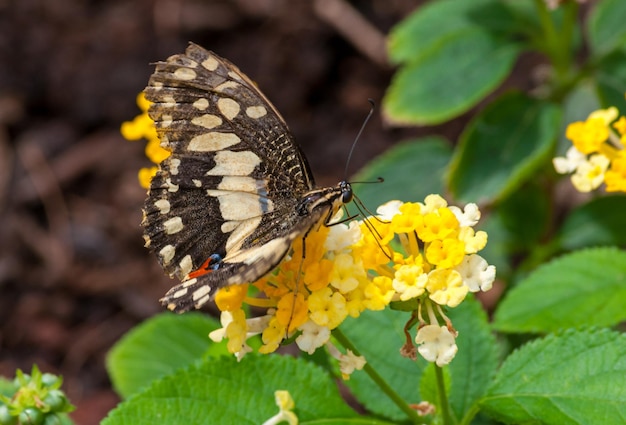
0 0 446 425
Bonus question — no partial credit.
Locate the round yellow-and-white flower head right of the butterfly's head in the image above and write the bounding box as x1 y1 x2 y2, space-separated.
357 195 495 307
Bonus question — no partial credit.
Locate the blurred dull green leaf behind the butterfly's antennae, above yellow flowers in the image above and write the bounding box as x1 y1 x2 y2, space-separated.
352 137 452 209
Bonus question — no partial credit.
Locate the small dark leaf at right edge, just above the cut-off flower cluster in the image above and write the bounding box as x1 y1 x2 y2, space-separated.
594 49 626 113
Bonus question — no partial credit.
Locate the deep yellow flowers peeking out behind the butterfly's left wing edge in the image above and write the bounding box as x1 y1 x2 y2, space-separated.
120 92 170 189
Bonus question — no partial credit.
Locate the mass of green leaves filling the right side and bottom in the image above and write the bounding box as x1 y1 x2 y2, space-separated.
105 0 626 425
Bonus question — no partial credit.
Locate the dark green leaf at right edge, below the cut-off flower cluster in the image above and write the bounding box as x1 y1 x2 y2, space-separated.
556 195 626 250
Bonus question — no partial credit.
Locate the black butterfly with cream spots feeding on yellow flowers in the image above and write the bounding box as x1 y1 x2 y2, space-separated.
142 43 353 312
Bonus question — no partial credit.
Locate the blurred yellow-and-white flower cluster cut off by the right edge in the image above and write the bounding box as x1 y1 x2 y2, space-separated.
553 107 626 192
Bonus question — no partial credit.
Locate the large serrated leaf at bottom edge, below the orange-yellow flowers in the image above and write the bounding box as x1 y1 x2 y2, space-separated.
102 354 358 425
